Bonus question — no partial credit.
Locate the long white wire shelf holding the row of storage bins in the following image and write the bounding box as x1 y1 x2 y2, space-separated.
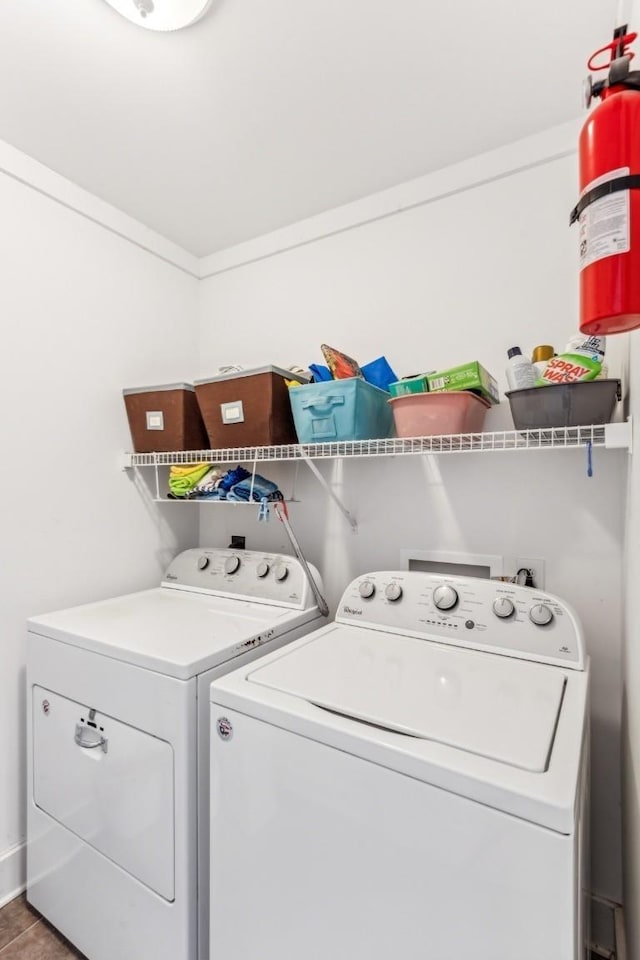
124 420 631 467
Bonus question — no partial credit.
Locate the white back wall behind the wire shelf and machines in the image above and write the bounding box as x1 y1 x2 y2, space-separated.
199 125 626 899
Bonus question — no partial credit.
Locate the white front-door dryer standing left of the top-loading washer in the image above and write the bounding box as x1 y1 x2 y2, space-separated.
27 549 324 960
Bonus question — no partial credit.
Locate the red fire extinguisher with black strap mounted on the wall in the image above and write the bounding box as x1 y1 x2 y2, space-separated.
570 26 640 334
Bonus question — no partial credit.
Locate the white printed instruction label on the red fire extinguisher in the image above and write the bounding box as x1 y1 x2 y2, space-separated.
578 167 631 270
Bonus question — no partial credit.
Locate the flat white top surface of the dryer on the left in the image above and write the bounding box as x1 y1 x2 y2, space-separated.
28 587 318 680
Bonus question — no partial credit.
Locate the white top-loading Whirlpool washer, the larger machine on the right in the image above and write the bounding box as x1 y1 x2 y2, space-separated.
211 572 589 960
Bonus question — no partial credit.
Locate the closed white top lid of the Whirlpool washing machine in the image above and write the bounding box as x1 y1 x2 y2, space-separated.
248 627 566 773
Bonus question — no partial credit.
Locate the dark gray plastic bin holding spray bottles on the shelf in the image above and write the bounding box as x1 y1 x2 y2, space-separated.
505 380 622 430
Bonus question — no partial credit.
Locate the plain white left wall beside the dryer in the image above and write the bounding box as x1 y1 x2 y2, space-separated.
0 151 198 904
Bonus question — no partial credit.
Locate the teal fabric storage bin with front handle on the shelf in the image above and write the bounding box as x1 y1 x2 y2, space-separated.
289 377 395 443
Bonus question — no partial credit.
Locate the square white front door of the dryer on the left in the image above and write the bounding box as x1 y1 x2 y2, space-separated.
32 686 174 900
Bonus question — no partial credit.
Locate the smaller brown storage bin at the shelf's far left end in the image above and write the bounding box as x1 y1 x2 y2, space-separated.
122 383 209 453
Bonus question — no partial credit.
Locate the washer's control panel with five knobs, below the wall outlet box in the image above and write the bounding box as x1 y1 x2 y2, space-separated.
336 570 584 670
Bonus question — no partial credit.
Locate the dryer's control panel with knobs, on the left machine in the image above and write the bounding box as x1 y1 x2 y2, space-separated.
162 547 322 610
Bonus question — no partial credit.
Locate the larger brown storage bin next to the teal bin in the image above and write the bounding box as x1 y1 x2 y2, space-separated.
195 367 307 449
